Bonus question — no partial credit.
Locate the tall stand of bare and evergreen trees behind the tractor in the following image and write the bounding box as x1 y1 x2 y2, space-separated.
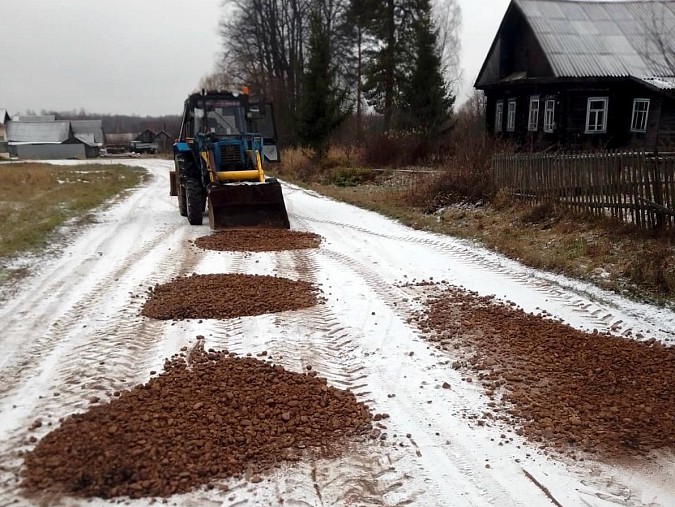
214 0 460 162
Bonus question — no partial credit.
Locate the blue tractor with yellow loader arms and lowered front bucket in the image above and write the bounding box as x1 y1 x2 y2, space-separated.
171 88 290 230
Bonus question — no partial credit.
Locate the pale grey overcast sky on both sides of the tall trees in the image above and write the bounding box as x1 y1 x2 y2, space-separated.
0 0 509 116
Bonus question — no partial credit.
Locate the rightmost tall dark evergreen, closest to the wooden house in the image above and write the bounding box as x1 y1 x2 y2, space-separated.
400 0 455 139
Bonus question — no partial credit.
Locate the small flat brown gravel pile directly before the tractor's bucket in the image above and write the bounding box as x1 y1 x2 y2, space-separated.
195 229 321 252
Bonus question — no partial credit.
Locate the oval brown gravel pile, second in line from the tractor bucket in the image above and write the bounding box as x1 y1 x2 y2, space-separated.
141 274 319 320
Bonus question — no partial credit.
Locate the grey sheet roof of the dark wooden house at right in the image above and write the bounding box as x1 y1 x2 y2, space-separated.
477 0 675 89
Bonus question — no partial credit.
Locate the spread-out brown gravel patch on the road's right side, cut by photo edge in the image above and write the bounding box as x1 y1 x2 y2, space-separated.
419 288 675 455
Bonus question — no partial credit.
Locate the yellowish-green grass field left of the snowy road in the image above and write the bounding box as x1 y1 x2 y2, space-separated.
0 162 146 270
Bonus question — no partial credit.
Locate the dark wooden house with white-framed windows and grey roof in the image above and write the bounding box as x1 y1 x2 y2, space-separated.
475 0 675 151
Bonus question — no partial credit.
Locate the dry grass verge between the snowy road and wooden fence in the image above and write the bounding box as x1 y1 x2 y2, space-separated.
290 175 675 306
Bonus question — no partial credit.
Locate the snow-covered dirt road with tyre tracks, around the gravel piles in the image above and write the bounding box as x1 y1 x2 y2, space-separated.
0 160 675 507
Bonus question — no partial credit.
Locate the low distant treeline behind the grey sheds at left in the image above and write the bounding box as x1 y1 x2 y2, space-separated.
35 109 181 137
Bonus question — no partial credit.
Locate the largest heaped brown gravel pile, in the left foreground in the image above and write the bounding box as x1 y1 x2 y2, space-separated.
22 349 371 498
